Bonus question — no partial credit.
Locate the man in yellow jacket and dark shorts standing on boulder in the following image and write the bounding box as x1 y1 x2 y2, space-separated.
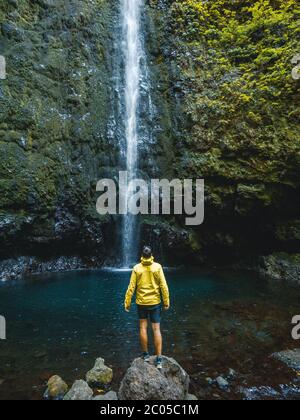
125 246 170 369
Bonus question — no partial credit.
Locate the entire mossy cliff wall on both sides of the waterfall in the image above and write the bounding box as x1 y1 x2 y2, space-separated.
0 0 300 270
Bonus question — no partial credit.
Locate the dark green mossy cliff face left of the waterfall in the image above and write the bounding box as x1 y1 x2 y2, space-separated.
0 0 118 260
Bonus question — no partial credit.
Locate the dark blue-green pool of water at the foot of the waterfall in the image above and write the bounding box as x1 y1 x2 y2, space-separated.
0 270 300 399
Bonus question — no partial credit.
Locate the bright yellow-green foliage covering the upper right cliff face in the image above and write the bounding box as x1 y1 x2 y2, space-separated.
170 0 300 185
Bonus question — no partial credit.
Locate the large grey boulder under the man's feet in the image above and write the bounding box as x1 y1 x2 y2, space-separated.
118 357 190 401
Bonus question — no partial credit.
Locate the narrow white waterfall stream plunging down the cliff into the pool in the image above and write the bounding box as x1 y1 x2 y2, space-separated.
121 0 143 267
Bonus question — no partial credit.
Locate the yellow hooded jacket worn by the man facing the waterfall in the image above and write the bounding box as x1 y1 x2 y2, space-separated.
125 257 170 309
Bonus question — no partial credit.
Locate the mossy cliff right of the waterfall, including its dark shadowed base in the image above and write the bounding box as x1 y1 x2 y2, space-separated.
145 0 300 261
